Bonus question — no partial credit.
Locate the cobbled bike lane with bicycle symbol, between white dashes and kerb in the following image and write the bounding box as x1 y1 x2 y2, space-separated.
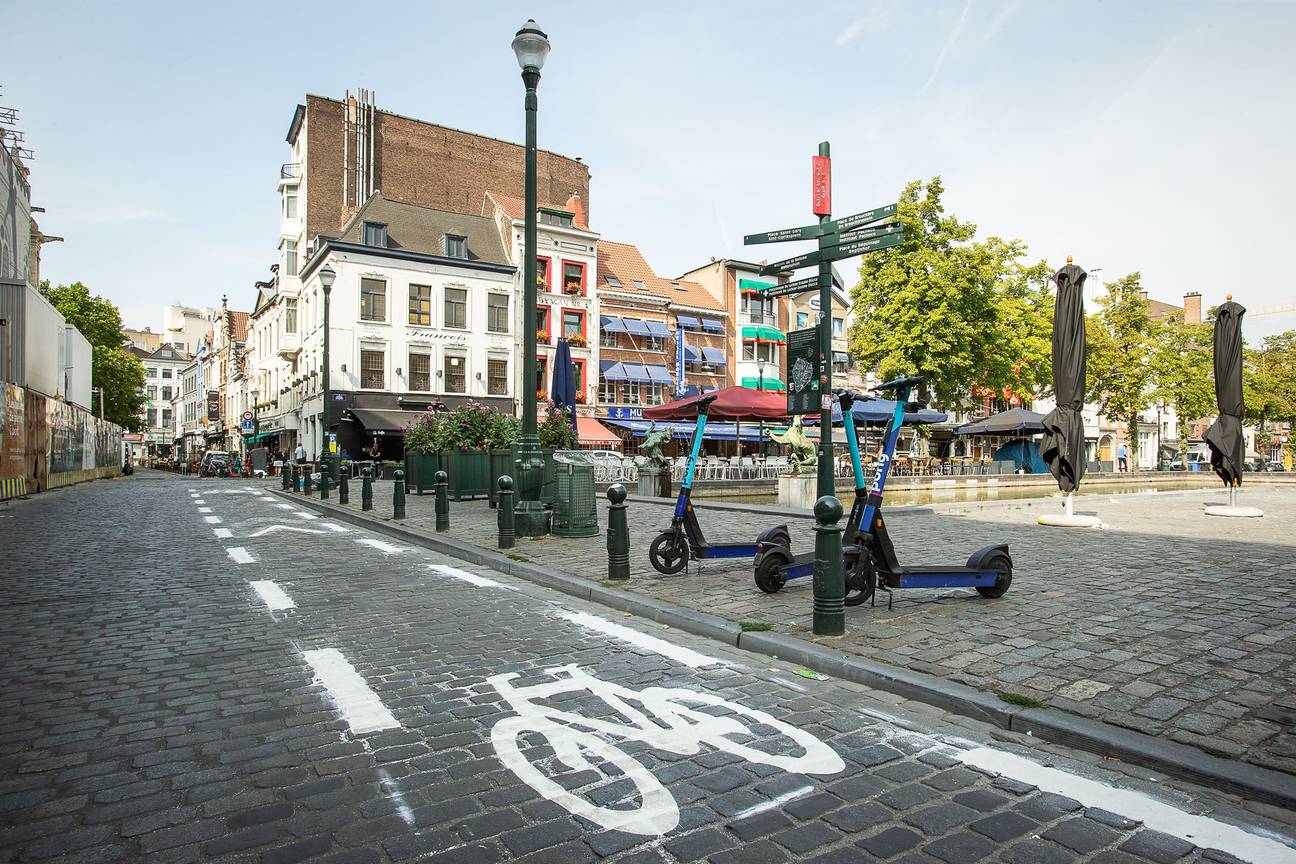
204 484 1296 864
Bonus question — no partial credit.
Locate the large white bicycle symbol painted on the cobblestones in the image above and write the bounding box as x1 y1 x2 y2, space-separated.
486 665 846 836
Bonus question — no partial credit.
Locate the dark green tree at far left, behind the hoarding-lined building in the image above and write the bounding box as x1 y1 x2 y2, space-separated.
40 280 144 431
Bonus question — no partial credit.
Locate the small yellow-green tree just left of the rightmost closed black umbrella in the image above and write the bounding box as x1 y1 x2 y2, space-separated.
1148 312 1216 452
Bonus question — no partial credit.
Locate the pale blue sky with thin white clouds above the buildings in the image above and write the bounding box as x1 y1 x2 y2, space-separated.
10 0 1296 341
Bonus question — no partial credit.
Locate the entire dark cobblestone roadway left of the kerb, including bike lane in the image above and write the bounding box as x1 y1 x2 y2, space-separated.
0 470 1296 864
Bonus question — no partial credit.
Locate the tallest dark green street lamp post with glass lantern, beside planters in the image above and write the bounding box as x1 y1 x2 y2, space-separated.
510 18 550 538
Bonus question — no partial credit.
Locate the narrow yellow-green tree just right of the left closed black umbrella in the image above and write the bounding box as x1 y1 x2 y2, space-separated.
1085 273 1153 459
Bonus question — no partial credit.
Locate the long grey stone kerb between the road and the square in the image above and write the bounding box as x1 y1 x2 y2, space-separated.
276 490 1296 810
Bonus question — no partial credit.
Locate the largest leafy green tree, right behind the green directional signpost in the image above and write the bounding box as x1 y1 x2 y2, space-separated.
850 177 1052 407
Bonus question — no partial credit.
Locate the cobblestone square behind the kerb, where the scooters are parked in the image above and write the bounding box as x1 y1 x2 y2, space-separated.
355 483 1296 772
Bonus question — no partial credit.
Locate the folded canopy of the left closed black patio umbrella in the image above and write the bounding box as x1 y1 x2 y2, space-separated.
1039 258 1089 492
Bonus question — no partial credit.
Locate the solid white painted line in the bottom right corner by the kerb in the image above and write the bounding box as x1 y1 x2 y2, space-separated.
955 747 1296 864
